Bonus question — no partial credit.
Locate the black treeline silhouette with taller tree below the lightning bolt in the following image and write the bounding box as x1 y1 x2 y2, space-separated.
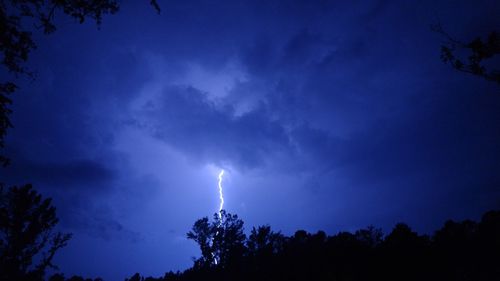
132 208 500 281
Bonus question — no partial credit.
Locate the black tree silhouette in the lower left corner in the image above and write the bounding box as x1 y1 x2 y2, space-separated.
0 185 71 281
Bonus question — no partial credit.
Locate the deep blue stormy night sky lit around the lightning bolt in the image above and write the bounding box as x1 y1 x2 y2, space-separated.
1 0 500 280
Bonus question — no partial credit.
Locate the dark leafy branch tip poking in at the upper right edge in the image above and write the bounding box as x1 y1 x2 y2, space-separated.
432 24 500 84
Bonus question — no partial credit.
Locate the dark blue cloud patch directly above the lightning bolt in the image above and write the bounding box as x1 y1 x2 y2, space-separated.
137 86 289 168
